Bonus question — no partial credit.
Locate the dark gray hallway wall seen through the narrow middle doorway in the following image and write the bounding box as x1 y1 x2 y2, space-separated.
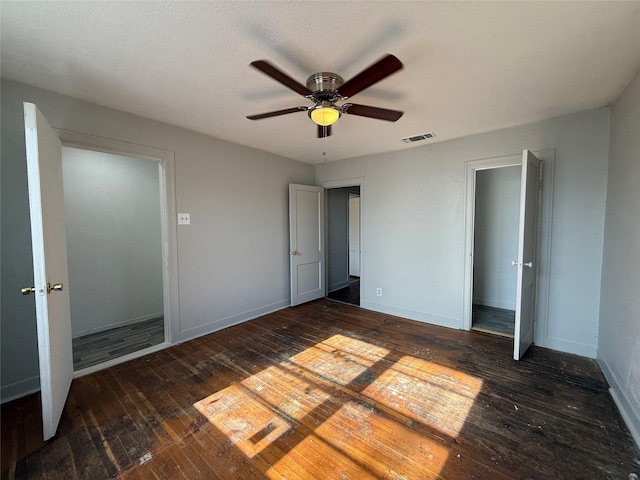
326 188 349 292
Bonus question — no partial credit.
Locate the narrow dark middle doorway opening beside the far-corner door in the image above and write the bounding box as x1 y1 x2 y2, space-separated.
326 185 361 306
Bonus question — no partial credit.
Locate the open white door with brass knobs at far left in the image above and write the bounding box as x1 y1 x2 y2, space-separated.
22 103 73 440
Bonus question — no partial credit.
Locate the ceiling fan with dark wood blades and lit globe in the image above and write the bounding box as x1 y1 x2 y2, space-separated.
247 54 404 138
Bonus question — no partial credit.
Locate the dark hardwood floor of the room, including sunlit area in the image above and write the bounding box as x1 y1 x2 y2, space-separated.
2 299 640 480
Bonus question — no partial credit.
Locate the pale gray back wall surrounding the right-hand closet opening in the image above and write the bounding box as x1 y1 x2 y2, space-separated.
316 108 609 357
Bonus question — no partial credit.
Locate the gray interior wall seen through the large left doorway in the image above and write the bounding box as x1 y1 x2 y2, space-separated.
62 147 163 337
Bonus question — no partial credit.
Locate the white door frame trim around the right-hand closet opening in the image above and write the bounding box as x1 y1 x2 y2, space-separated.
460 149 555 346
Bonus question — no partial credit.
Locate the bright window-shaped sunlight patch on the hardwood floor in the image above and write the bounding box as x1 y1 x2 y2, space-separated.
194 335 482 479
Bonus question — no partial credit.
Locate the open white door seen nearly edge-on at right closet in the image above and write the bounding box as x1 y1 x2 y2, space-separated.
513 150 542 360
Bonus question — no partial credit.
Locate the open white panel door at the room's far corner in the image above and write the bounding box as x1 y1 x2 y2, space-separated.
289 184 326 306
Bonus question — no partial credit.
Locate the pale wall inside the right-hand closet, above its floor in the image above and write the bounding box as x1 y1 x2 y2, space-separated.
473 167 521 310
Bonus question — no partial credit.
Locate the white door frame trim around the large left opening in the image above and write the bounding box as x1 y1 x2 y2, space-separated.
54 129 179 377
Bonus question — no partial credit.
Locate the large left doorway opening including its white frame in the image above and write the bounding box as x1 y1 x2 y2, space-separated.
56 130 179 377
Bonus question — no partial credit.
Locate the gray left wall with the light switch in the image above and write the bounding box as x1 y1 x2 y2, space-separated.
0 79 314 400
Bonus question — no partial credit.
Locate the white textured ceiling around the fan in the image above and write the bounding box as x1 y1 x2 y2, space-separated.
0 1 640 163
